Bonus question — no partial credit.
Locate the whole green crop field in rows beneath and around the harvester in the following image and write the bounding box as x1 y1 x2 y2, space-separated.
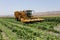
0 17 60 40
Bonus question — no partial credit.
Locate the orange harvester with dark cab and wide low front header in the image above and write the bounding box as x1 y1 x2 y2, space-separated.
14 10 44 23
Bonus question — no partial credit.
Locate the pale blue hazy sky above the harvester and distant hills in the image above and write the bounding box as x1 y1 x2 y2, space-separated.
0 0 60 16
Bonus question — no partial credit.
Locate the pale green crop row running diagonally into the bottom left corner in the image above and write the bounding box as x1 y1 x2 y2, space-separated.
0 22 17 40
